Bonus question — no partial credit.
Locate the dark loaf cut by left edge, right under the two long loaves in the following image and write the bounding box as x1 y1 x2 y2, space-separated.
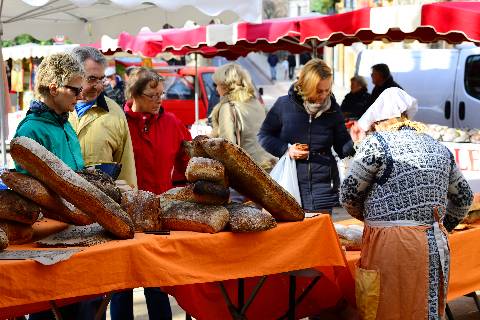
0 190 40 225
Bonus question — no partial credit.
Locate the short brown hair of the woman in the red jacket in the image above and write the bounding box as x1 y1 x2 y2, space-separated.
125 67 164 99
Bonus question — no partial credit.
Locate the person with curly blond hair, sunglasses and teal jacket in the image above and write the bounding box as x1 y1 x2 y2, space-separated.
15 53 84 320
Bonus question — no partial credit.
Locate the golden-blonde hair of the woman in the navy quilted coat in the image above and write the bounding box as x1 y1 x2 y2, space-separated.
295 59 332 98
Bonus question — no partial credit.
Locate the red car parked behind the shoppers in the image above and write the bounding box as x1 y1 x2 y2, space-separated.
155 66 263 127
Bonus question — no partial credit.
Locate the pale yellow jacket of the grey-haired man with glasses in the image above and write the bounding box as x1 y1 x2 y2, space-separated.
68 97 137 187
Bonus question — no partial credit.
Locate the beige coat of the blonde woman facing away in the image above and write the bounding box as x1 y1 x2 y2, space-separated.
211 98 278 171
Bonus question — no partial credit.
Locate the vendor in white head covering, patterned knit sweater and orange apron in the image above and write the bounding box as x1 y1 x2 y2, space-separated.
340 88 473 319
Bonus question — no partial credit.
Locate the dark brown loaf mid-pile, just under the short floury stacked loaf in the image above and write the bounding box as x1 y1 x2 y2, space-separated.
164 180 230 205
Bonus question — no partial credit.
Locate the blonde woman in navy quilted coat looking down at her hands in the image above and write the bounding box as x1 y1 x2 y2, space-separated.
258 59 354 211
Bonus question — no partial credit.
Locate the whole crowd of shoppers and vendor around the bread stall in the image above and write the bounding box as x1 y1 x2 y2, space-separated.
10 47 472 320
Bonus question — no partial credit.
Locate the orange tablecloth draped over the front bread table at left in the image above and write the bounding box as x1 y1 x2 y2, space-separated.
0 215 353 316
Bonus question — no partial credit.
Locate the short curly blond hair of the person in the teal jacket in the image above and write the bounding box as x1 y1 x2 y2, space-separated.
35 53 85 98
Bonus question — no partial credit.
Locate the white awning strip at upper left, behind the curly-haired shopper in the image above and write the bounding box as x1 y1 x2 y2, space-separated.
2 43 79 61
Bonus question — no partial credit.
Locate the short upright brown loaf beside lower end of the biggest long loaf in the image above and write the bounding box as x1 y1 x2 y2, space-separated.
122 190 162 232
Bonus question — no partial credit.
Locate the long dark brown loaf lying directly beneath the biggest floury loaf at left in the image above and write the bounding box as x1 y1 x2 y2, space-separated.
1 170 93 226
